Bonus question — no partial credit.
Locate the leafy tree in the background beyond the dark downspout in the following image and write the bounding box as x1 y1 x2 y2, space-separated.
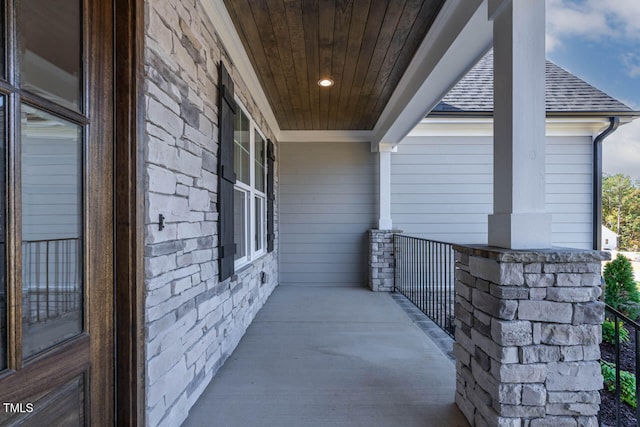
602 174 640 251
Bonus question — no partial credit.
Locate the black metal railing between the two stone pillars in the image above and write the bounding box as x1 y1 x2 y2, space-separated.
393 234 455 337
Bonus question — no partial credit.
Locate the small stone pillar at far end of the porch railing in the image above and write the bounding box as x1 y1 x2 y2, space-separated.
368 230 402 292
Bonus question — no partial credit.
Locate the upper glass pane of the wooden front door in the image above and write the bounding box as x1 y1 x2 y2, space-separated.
16 0 82 110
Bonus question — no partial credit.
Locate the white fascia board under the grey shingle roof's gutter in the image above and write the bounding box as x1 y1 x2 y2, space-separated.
407 117 631 137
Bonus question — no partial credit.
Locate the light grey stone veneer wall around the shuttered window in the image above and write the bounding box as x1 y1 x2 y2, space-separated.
141 0 278 426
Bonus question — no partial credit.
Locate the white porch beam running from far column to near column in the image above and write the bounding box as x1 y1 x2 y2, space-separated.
372 0 493 149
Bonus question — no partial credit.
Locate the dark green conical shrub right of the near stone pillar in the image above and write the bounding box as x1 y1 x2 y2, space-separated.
603 254 640 319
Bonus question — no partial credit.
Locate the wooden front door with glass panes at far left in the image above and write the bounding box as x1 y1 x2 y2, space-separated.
0 0 115 426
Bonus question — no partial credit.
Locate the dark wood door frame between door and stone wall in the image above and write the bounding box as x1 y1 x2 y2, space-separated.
114 0 145 426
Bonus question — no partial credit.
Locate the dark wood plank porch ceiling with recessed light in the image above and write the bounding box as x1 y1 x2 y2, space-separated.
224 0 444 130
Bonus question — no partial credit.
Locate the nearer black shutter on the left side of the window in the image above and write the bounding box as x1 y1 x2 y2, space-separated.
218 62 236 281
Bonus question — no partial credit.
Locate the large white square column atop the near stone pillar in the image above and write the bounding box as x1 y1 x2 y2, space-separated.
489 0 551 249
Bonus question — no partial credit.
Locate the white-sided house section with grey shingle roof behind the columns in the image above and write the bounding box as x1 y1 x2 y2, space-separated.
384 52 631 249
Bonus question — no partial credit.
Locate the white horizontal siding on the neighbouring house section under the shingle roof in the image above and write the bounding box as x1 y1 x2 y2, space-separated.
391 136 592 249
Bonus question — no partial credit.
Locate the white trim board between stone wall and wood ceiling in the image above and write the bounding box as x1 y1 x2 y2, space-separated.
202 0 280 140
